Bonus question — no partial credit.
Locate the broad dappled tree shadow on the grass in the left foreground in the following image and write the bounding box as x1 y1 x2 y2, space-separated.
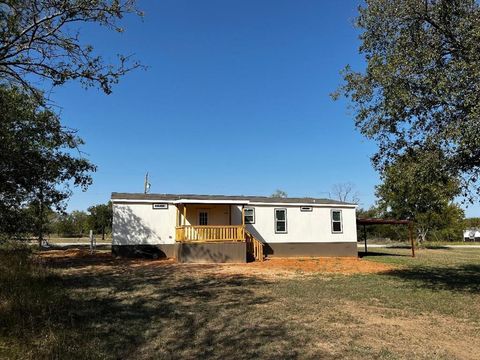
19 256 312 359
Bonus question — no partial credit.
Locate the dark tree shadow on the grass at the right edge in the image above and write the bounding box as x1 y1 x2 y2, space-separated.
386 264 480 294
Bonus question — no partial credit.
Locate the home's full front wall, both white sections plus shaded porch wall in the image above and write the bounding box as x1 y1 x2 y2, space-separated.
112 201 357 245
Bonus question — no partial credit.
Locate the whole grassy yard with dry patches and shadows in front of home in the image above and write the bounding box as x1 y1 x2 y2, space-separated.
0 243 480 359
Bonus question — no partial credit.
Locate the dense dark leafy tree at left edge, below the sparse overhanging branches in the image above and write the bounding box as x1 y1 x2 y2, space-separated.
0 86 95 241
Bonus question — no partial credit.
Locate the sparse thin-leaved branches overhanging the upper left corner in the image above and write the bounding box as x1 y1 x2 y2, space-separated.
0 0 141 97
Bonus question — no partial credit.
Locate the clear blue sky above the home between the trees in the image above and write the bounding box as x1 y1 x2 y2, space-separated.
44 0 478 215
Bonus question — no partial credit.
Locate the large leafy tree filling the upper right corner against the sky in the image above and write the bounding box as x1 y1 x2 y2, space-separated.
335 0 480 200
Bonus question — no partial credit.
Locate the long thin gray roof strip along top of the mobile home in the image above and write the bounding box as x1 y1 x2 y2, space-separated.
111 192 356 205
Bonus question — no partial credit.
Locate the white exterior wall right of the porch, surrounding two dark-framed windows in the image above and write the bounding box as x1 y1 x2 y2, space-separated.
232 205 357 243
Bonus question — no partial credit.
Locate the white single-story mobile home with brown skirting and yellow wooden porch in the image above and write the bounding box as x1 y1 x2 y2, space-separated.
112 193 357 262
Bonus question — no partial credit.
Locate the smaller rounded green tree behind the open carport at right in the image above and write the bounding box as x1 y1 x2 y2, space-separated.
376 153 463 241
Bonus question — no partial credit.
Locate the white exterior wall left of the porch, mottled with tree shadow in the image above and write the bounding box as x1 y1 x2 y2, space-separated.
112 202 177 245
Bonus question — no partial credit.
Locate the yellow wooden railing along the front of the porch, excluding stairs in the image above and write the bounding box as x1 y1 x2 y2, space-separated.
175 225 245 242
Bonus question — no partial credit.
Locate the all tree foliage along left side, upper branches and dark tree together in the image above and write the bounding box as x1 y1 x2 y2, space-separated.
0 0 142 240
